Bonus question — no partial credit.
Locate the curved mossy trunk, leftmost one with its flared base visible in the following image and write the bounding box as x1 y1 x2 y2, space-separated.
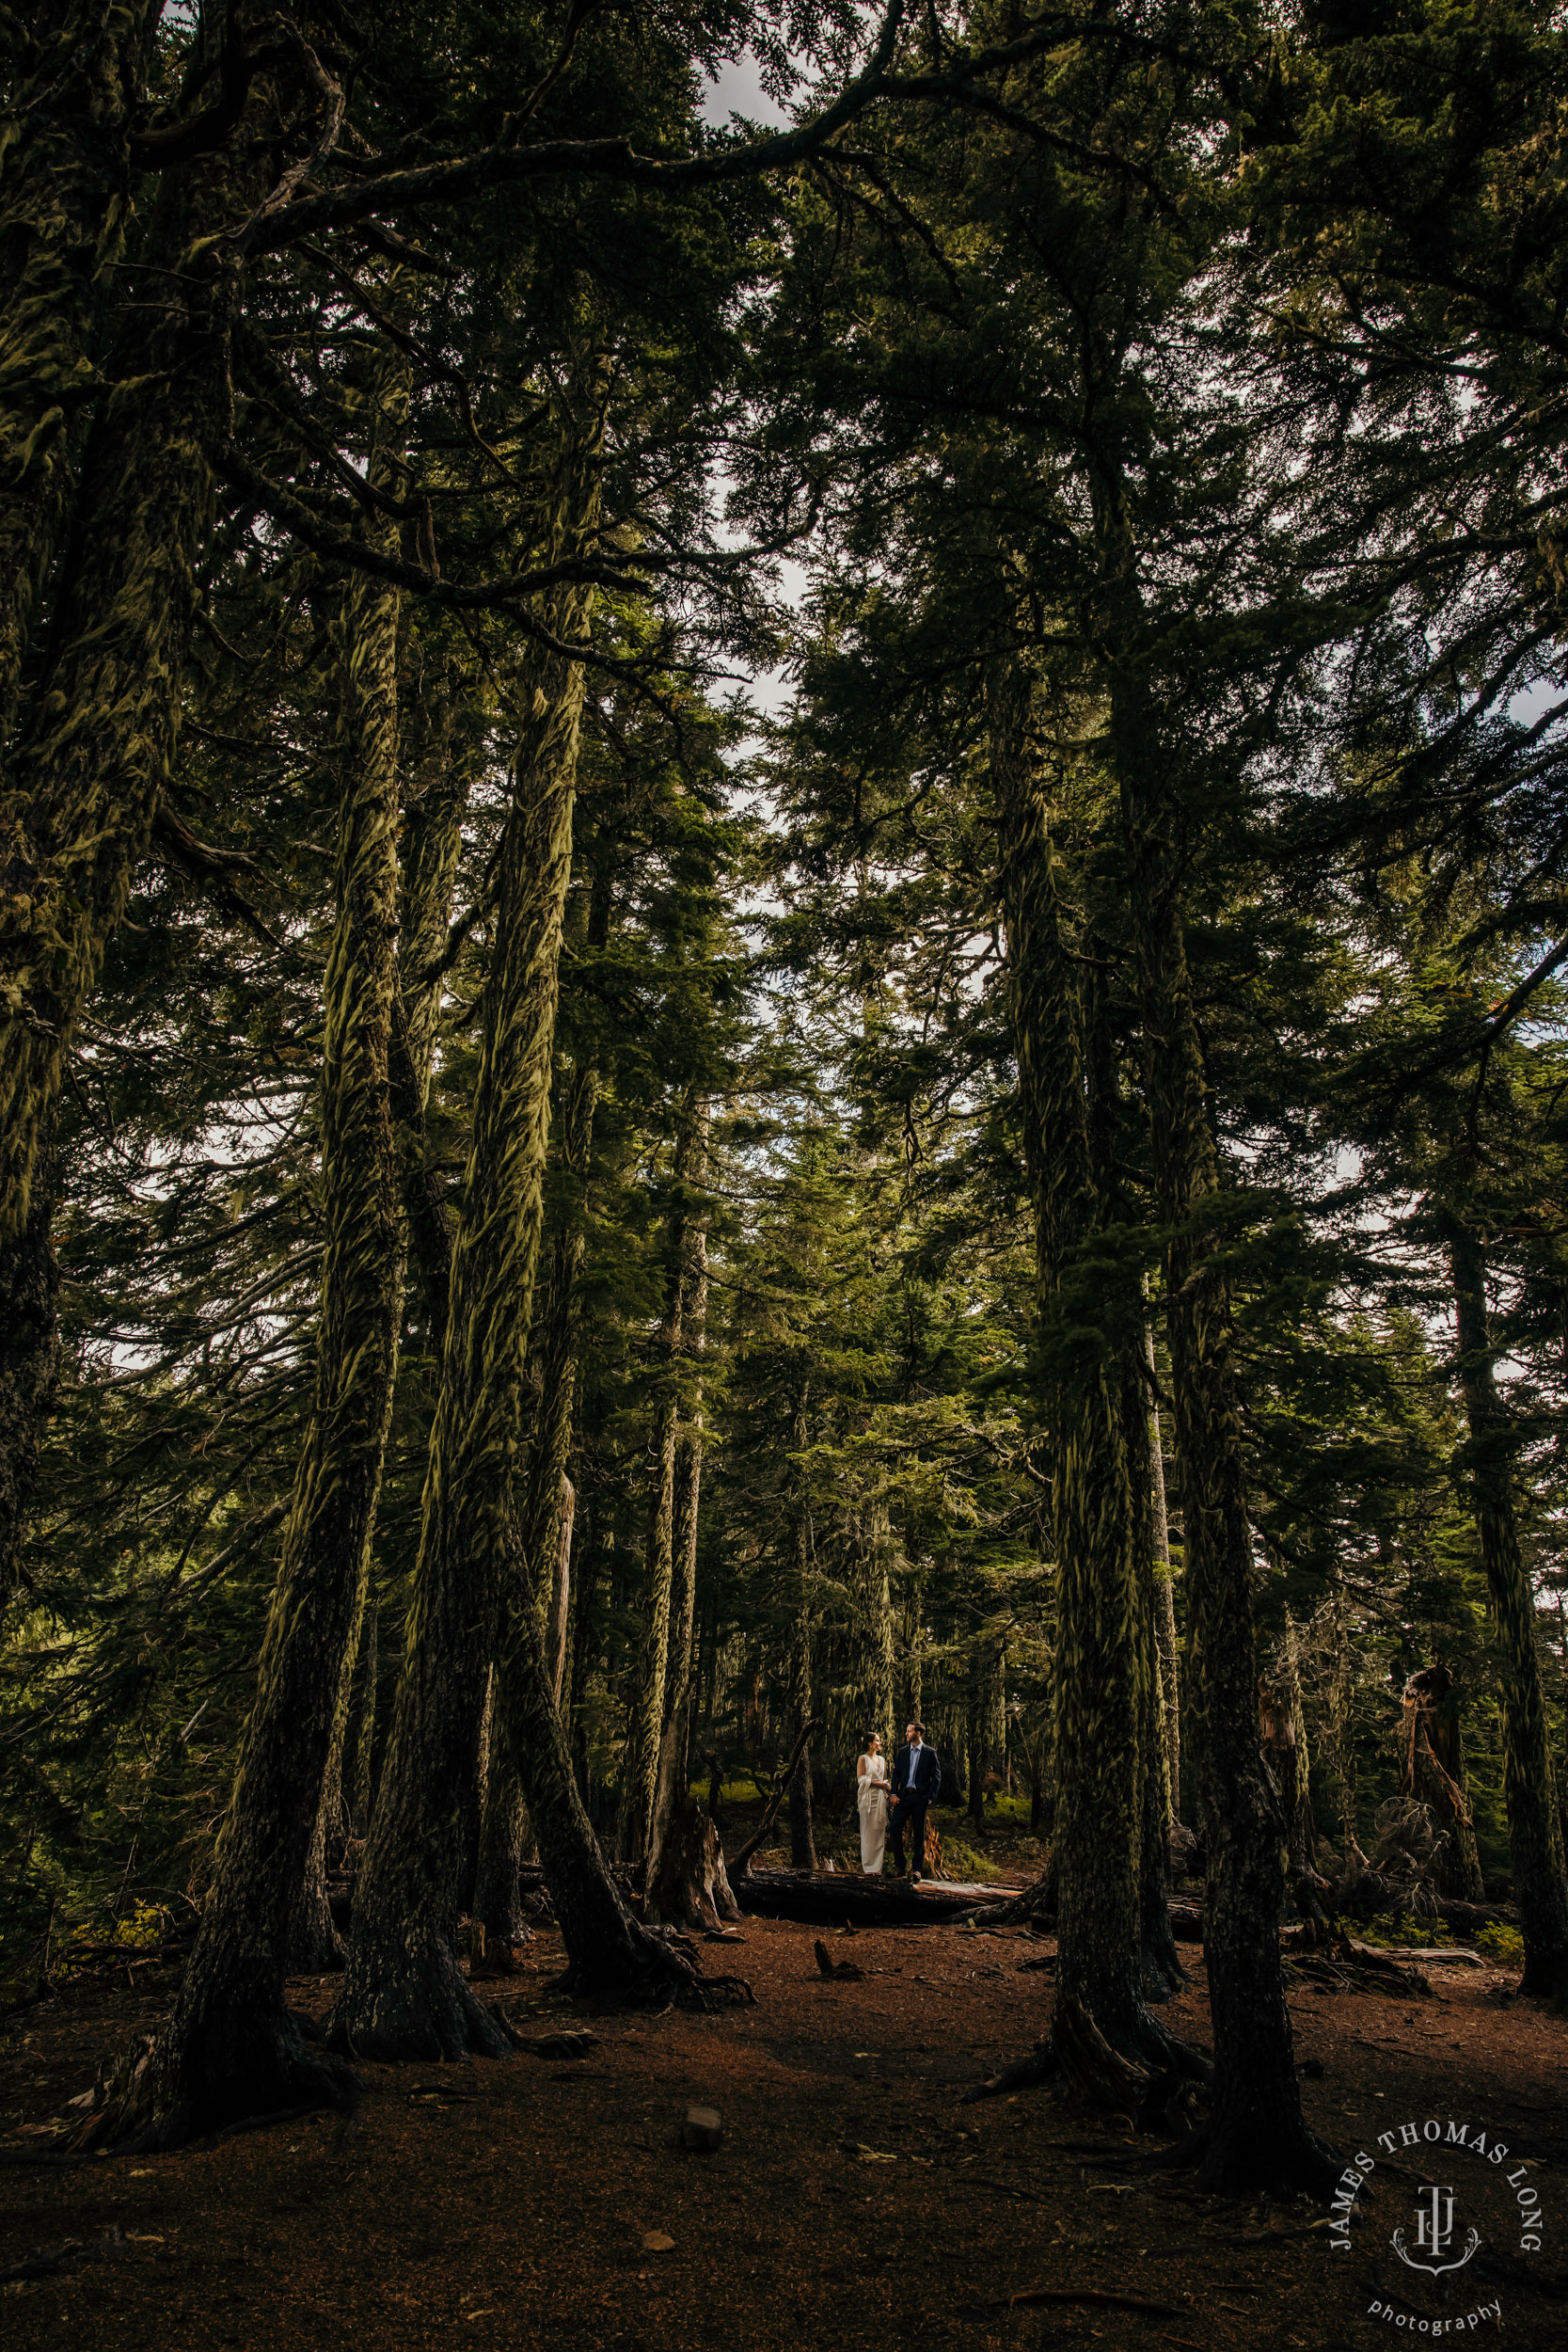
83 331 409 2145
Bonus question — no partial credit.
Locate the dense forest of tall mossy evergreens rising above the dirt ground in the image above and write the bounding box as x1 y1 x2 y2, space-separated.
0 0 1568 2187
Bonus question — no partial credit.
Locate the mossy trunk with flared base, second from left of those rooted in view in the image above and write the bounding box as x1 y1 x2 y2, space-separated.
331 491 593 2058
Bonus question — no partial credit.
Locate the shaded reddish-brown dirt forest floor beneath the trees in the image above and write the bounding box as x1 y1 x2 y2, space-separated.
0 1919 1568 2352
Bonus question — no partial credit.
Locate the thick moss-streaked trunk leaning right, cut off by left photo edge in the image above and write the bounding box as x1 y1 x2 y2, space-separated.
0 128 254 1245
